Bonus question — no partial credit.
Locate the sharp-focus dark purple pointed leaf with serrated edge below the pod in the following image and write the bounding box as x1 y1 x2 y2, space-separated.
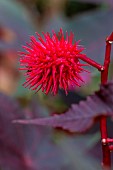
14 82 113 132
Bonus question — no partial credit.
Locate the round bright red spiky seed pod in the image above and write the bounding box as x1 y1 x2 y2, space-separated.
20 29 88 95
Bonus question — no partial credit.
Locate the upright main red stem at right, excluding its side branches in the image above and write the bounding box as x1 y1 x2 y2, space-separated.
100 41 111 170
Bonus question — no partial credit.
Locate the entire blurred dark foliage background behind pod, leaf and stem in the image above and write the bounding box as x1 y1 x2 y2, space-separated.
0 0 113 170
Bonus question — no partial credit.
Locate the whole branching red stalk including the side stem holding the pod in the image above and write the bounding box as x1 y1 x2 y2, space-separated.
81 33 113 170
